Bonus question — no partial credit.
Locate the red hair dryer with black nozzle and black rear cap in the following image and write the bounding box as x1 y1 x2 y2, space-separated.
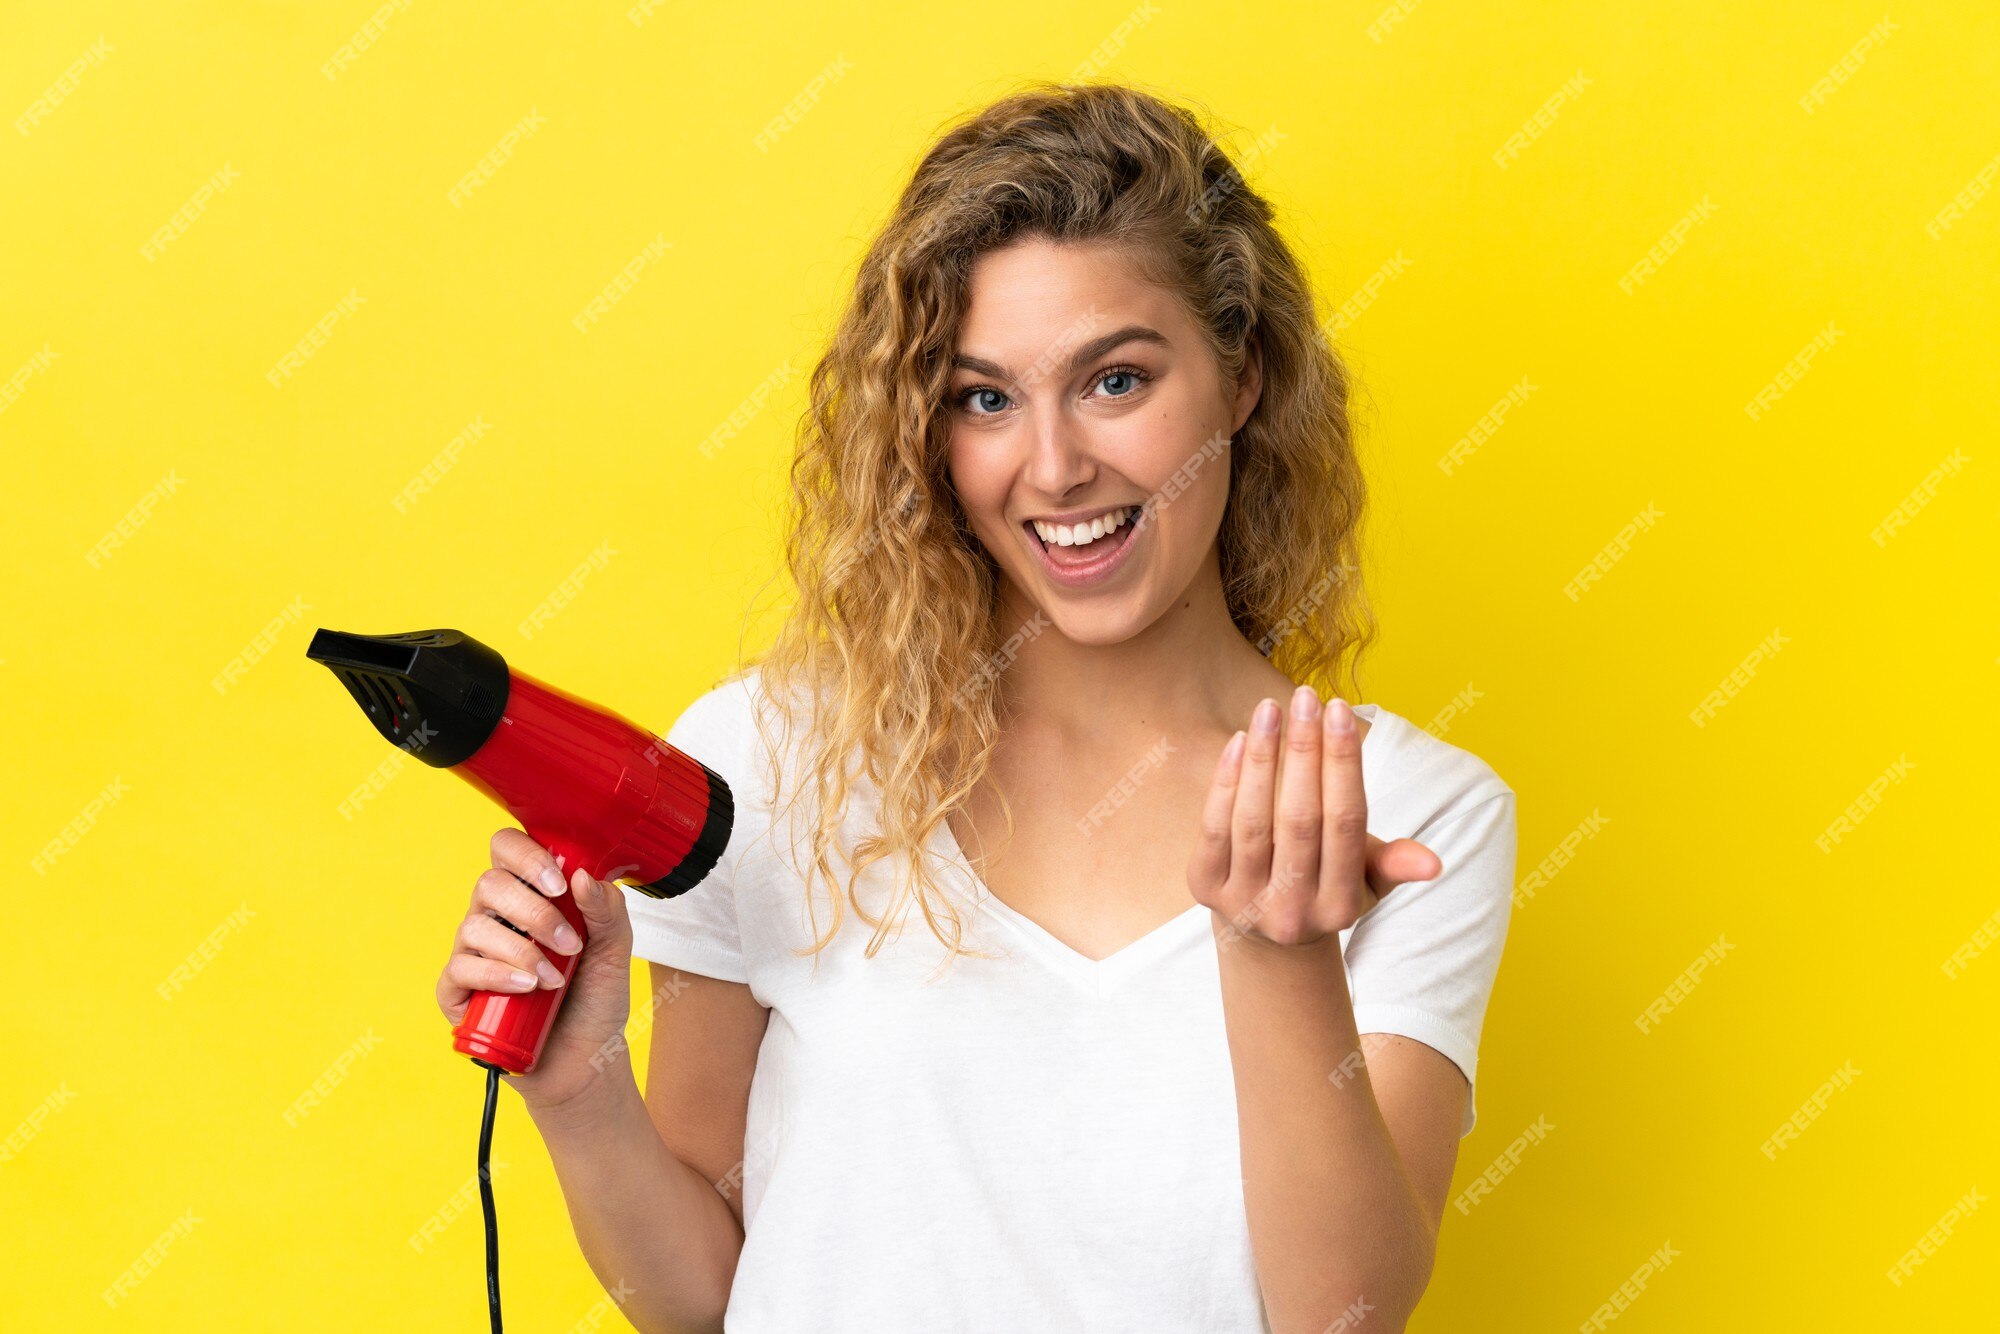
306 630 736 1074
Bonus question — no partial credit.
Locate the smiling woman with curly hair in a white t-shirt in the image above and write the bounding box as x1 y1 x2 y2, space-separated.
438 84 1514 1334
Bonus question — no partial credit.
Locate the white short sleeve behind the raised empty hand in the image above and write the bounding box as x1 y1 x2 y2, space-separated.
1346 788 1514 1138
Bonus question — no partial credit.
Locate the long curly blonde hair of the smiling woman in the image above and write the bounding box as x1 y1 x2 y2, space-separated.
736 80 1374 962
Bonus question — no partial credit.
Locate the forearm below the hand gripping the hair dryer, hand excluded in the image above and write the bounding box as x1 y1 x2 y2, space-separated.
530 1056 742 1334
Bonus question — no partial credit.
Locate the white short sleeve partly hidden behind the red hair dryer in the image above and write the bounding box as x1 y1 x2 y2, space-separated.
624 680 752 982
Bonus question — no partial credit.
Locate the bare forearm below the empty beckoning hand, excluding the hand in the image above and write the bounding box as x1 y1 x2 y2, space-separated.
1216 916 1436 1334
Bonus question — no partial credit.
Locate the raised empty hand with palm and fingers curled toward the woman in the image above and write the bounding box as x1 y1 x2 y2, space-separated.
1188 686 1444 946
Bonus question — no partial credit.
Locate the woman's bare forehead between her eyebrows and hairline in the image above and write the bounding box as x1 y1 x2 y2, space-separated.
956 238 1188 362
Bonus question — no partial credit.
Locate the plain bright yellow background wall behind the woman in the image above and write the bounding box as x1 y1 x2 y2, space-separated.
0 0 2000 1330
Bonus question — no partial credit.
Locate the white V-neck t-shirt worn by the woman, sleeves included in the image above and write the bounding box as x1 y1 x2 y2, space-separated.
626 670 1514 1334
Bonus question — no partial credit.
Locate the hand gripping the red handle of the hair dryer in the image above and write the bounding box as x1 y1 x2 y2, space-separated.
438 828 632 1108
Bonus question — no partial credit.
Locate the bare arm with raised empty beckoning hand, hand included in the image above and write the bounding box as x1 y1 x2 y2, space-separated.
1188 690 1466 1334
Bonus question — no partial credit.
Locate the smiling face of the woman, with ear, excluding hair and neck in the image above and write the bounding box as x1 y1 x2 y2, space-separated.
944 238 1258 644
